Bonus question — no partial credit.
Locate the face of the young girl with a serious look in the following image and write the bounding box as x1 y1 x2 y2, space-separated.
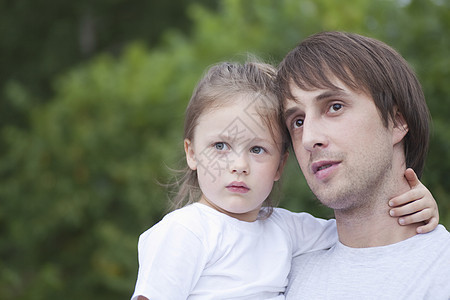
184 97 287 222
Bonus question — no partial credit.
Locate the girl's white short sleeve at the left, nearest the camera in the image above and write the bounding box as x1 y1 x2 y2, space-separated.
132 220 206 300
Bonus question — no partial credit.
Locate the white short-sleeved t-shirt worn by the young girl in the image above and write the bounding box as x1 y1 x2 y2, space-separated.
132 203 337 300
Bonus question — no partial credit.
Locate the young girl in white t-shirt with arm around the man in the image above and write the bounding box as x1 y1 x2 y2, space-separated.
132 62 436 300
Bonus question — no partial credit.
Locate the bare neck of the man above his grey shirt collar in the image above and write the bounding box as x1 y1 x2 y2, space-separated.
335 172 420 248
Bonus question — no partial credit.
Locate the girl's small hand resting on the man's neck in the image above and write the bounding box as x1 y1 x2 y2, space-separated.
389 168 439 233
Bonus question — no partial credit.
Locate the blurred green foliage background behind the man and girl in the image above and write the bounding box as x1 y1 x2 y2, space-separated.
0 0 450 299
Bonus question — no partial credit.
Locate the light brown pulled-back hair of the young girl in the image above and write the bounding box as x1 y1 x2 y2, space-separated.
172 61 290 215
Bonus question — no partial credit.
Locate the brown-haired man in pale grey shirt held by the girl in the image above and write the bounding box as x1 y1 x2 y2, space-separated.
278 32 450 299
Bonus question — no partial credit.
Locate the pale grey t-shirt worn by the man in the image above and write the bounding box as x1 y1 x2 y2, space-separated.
286 225 450 300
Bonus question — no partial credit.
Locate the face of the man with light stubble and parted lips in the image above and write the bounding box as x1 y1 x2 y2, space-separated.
284 80 401 210
